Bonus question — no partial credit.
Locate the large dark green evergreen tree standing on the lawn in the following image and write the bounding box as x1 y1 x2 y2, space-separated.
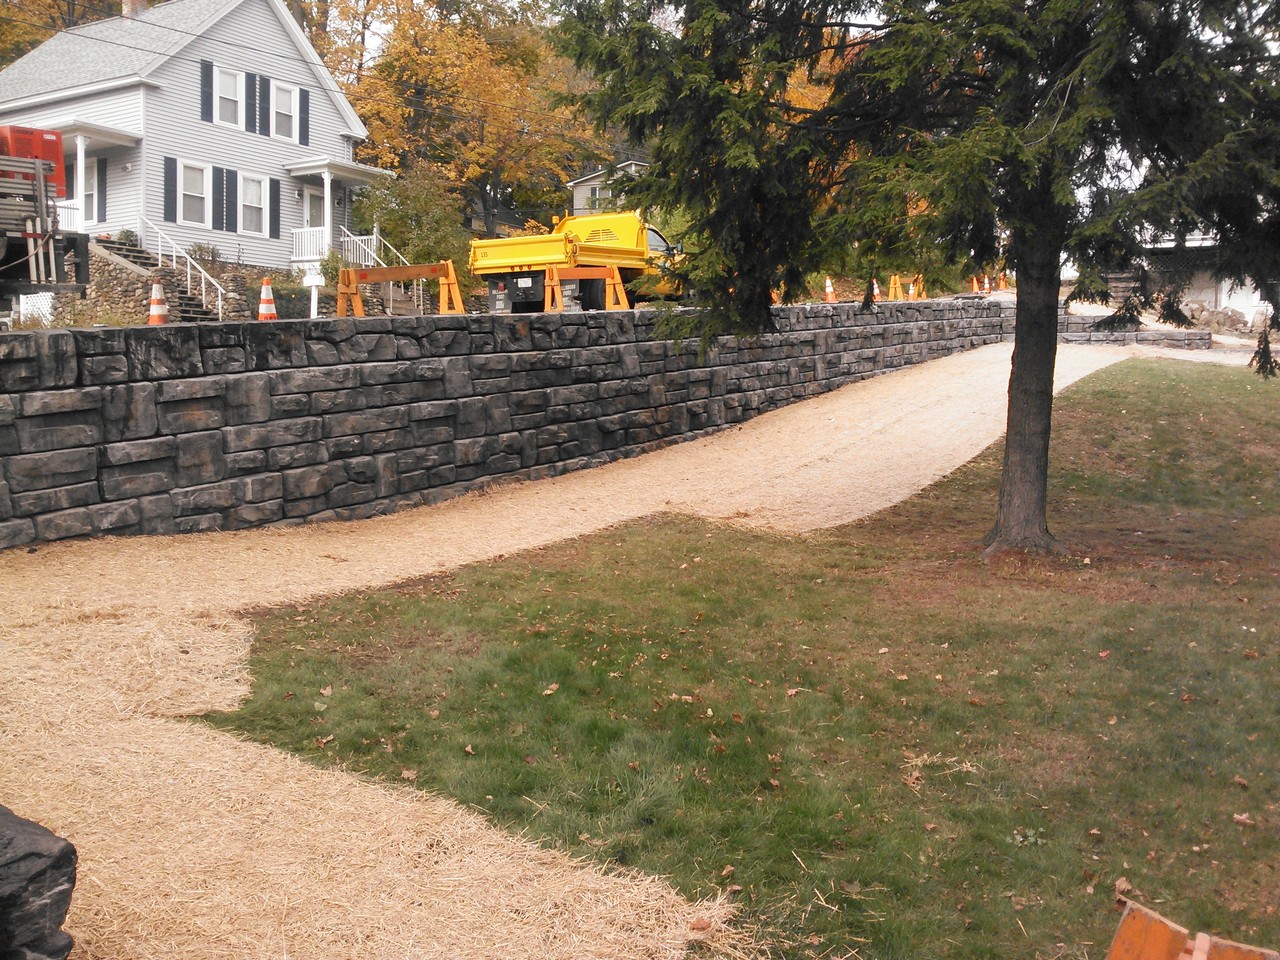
562 0 1280 550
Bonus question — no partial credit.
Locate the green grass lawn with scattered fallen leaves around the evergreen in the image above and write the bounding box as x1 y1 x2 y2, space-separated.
207 361 1280 960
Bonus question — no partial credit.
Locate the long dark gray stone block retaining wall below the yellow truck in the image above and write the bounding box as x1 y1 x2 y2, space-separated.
0 300 1208 548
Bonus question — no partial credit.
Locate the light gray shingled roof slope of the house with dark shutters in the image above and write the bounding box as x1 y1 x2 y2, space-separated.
0 0 239 105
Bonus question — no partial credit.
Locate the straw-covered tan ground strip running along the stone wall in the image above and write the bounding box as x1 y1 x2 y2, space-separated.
0 346 1239 960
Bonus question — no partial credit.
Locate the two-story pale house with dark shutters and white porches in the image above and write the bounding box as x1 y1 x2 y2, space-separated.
0 0 383 268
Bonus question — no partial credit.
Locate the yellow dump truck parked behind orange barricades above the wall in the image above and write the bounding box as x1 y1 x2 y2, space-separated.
470 211 678 314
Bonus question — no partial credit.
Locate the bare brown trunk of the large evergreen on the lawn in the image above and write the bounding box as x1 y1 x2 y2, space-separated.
986 232 1064 554
